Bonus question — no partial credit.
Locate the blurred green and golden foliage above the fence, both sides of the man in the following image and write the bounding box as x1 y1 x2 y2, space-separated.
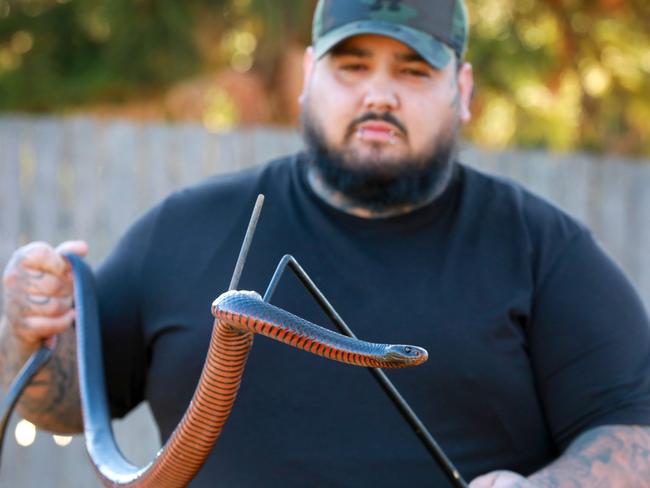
0 0 650 155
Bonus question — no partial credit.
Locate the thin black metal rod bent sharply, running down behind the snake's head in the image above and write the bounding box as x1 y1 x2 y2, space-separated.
264 255 468 488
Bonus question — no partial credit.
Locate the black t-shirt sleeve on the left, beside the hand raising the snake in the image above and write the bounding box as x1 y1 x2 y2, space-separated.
95 207 160 417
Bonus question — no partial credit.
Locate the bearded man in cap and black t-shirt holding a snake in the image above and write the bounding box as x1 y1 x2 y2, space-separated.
1 0 650 487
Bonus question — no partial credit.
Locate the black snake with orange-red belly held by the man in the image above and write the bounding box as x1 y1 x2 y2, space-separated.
0 254 428 488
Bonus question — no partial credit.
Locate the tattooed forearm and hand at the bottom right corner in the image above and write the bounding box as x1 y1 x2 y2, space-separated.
470 425 650 488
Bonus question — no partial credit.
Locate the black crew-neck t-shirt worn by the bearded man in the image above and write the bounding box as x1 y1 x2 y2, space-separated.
93 156 650 488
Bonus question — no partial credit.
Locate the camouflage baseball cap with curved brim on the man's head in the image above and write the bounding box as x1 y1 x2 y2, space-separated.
313 0 468 69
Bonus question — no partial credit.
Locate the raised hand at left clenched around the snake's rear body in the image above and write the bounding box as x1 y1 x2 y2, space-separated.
3 241 88 350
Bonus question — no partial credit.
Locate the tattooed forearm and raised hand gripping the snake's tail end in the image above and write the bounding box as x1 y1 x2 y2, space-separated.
0 242 87 433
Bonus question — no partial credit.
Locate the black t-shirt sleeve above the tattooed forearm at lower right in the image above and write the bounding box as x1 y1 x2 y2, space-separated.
528 230 650 449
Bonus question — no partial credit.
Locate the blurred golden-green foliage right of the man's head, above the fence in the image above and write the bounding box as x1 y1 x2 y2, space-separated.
460 0 650 155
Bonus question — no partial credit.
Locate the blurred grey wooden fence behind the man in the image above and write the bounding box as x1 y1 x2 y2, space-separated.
0 116 650 488
